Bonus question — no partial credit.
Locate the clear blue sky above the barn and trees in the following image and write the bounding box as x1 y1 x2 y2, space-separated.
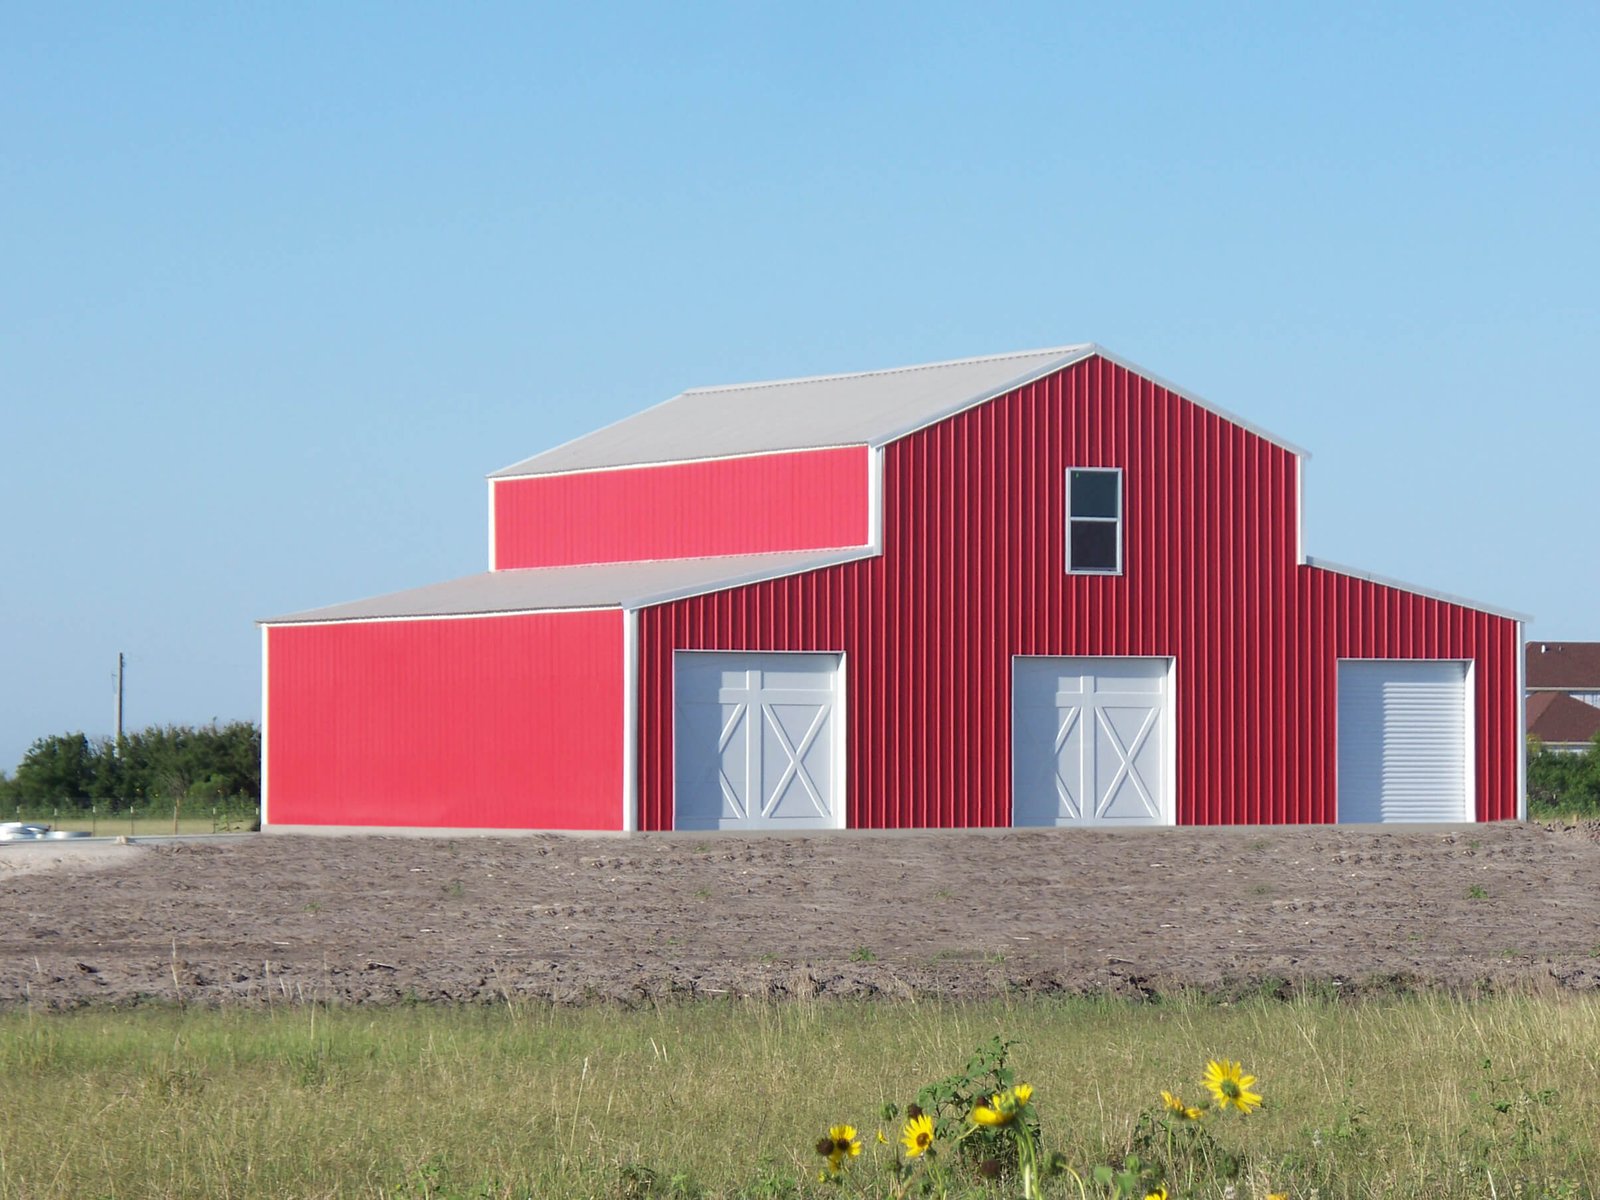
0 3 1600 770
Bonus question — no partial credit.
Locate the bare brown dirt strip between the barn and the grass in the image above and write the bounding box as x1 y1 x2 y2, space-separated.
0 824 1600 1008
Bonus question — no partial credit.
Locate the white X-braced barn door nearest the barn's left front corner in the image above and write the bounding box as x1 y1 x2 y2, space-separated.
672 651 845 829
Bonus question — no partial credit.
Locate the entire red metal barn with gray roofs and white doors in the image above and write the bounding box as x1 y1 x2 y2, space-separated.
264 346 1523 830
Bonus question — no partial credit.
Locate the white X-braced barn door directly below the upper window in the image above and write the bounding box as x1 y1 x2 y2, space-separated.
1011 658 1173 826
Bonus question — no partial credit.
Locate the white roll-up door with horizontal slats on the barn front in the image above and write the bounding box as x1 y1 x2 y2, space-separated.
1339 659 1474 824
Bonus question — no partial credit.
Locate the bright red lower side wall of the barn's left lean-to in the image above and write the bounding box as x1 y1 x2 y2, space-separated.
266 611 622 829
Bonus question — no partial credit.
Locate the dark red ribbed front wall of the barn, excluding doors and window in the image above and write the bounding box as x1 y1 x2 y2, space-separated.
640 358 1520 829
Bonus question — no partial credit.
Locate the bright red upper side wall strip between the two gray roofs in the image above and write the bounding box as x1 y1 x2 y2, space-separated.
494 446 869 570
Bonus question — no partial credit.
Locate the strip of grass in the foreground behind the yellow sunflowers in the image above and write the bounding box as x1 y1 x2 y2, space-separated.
0 997 1600 1200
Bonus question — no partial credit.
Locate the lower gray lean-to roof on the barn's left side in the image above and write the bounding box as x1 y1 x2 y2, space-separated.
259 546 877 626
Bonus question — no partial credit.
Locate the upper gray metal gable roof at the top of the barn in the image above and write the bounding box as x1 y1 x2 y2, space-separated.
490 342 1306 478
